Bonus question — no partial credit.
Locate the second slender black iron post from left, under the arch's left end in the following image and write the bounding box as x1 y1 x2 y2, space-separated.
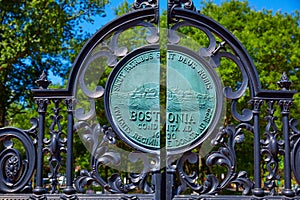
64 98 75 195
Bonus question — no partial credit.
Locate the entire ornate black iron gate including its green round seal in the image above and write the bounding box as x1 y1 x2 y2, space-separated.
0 0 300 199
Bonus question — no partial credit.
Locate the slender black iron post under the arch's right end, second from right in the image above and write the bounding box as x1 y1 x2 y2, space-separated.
252 99 264 196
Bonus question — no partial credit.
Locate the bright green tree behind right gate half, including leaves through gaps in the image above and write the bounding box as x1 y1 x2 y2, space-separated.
181 0 300 184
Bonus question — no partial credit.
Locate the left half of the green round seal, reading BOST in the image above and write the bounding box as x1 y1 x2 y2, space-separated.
105 48 160 152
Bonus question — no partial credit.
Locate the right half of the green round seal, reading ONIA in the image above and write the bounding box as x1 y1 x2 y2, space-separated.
166 46 223 154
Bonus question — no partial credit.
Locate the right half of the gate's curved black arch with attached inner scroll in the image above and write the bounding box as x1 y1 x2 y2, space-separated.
170 7 261 99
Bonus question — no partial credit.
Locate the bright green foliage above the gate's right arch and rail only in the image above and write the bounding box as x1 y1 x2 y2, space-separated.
201 0 300 89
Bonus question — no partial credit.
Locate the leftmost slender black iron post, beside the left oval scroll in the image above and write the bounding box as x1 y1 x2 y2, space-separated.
33 99 49 195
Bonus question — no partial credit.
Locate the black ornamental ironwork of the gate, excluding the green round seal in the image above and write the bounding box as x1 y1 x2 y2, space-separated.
0 0 300 199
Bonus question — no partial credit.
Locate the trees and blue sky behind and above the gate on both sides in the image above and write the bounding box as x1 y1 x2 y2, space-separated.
0 0 300 195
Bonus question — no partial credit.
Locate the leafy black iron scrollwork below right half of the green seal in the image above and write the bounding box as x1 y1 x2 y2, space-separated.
171 123 253 194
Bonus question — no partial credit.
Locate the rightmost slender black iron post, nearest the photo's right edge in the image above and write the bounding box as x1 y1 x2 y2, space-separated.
279 100 295 197
